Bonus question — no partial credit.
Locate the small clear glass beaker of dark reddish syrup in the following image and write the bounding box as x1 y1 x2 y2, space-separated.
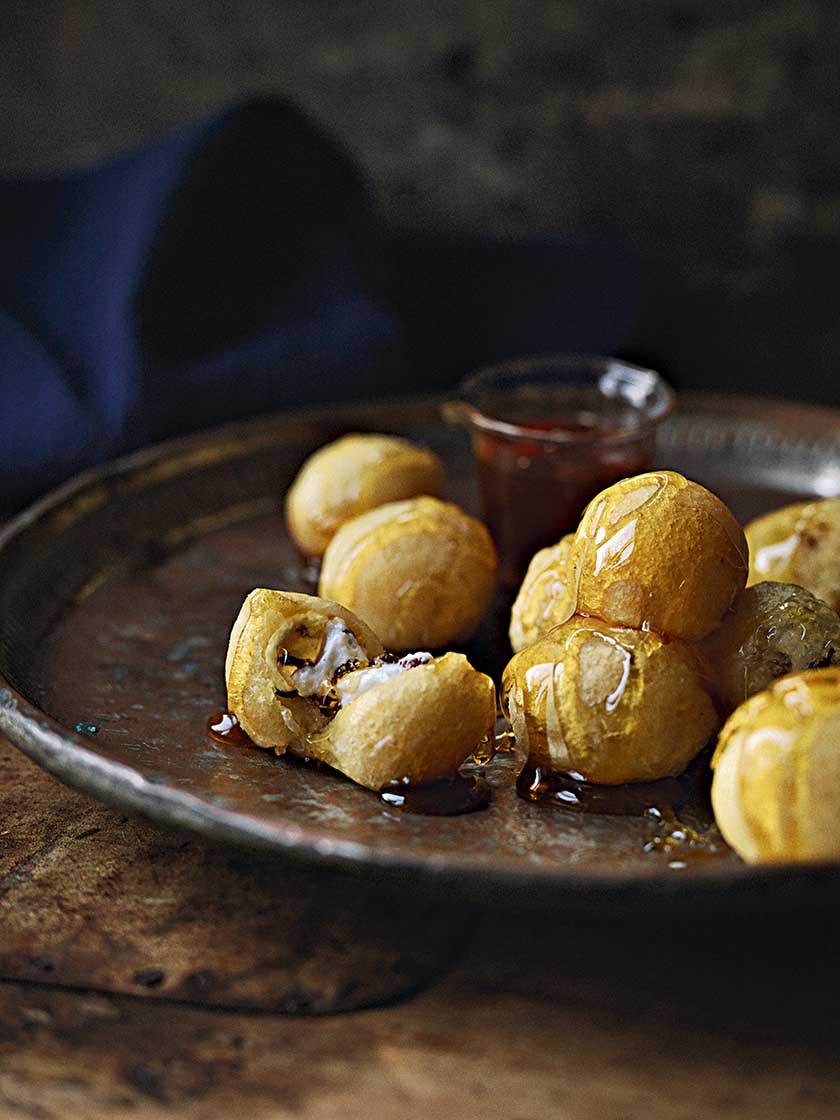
444 354 674 584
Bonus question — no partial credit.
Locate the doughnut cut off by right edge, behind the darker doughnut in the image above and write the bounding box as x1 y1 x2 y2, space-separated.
745 497 840 612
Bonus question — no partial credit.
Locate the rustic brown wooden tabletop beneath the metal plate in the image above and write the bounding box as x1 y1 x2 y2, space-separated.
0 744 840 1120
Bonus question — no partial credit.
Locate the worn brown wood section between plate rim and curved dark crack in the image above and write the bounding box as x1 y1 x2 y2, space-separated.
0 744 464 1014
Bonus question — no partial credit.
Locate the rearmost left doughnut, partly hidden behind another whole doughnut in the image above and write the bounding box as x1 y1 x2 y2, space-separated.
286 433 444 557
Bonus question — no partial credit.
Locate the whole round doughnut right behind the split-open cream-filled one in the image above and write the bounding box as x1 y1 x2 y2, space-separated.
319 497 497 650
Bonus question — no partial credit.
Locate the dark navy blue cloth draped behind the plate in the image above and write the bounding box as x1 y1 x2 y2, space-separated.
0 100 643 513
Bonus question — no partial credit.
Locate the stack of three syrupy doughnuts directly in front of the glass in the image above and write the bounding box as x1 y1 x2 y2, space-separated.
502 472 747 785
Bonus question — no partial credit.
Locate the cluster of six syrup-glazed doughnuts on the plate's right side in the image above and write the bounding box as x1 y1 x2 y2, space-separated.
502 472 840 862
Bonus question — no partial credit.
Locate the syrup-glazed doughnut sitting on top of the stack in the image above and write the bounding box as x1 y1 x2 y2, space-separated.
568 470 747 641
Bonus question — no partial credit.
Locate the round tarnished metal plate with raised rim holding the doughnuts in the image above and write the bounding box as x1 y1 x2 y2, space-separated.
0 396 840 909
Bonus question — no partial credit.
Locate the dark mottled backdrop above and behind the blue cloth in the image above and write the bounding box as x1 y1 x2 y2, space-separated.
0 0 840 403
